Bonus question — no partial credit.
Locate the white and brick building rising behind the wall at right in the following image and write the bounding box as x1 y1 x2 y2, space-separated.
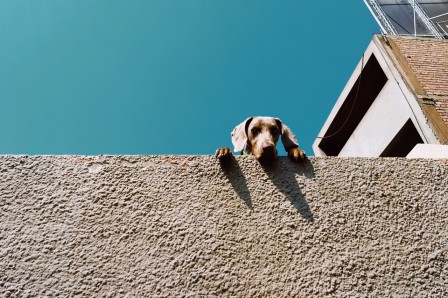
313 35 448 157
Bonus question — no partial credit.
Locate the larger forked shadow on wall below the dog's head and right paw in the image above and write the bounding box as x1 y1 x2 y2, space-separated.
260 157 314 223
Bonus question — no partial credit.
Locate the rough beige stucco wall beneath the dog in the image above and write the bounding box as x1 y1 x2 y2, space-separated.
0 156 448 297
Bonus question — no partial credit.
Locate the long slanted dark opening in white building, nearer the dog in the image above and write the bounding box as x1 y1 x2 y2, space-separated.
319 54 387 156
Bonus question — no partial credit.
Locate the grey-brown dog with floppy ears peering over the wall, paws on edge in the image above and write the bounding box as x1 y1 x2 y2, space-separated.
215 117 306 163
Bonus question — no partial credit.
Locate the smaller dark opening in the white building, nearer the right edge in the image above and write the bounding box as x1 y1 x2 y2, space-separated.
380 119 423 157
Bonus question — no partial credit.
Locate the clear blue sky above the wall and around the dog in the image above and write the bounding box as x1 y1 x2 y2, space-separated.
0 0 379 155
